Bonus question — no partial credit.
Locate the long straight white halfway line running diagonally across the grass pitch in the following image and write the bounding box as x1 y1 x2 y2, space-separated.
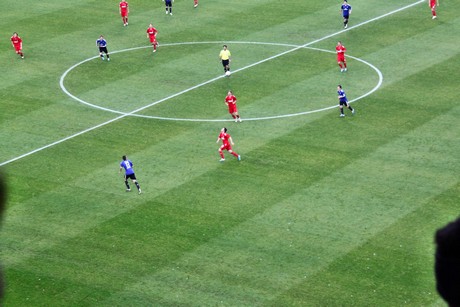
0 0 425 166
